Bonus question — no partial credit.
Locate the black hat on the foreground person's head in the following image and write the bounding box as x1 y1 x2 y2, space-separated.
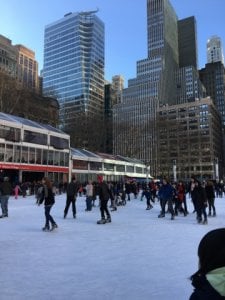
198 228 225 274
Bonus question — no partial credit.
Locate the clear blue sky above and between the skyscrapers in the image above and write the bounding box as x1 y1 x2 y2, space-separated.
0 0 225 82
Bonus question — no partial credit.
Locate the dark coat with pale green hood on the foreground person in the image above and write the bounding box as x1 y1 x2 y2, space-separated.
189 268 225 300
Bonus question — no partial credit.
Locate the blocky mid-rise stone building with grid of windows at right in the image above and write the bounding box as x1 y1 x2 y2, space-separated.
157 97 223 181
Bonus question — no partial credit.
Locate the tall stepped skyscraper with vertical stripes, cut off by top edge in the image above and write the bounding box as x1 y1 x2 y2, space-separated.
113 0 179 171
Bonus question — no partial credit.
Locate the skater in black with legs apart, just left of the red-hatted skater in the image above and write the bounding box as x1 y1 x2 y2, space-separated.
64 177 79 219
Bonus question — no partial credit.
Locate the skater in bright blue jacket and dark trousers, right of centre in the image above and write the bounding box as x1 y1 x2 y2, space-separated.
158 178 175 220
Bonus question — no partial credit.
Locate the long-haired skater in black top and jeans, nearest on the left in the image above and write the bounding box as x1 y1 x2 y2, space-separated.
39 177 58 231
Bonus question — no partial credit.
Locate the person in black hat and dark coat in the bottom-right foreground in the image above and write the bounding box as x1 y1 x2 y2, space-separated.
189 228 225 300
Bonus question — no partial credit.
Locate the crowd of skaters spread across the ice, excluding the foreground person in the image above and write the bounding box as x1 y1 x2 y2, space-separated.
0 175 225 226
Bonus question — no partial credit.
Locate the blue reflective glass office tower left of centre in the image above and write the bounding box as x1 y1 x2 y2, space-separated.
43 11 105 150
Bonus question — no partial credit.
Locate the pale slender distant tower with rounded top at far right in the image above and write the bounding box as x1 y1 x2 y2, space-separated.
207 36 224 64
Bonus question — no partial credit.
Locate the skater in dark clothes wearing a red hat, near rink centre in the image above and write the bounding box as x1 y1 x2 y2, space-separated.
97 175 113 224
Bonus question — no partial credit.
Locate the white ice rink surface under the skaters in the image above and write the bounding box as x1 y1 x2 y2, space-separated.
0 194 225 300
